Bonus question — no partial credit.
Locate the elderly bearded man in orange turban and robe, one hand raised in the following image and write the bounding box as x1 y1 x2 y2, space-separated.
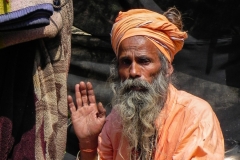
68 8 224 160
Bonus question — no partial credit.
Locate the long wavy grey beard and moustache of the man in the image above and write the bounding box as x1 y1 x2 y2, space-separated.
112 72 169 159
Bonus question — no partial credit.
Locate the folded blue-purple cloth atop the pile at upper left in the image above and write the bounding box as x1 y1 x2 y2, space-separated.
0 3 53 31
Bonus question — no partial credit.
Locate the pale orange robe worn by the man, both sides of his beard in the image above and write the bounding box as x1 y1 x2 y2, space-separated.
98 85 224 160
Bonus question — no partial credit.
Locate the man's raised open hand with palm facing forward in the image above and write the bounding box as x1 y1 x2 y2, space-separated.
68 82 106 148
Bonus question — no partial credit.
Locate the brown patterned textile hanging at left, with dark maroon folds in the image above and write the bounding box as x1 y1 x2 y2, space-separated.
0 0 73 160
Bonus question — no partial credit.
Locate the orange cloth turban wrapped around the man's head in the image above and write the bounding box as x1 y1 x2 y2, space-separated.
111 9 187 62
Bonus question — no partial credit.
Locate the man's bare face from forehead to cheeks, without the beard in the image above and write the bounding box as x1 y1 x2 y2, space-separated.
118 36 161 84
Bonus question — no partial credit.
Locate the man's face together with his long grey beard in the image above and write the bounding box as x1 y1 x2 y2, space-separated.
112 36 170 159
